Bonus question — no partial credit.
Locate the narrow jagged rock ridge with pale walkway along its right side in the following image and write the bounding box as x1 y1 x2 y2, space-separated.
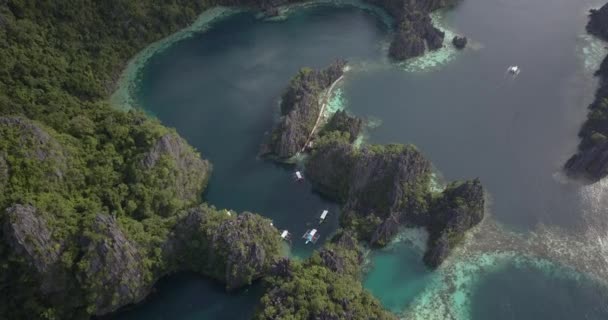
260 60 346 160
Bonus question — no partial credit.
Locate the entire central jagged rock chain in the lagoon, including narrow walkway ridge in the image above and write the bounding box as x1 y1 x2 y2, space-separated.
263 61 485 268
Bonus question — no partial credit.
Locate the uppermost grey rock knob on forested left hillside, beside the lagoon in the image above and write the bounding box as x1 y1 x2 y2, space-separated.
142 133 211 203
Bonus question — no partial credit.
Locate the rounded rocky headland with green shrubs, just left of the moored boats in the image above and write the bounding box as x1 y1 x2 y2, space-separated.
164 206 280 290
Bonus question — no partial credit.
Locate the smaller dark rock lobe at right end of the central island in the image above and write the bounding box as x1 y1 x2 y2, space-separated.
423 179 485 268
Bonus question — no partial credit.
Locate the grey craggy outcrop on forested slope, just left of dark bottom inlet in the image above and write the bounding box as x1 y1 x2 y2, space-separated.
77 214 150 315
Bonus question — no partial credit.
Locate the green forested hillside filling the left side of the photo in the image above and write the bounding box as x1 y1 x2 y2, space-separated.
0 0 278 319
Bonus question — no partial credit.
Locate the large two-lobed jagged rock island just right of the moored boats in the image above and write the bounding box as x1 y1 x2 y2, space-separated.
306 135 484 268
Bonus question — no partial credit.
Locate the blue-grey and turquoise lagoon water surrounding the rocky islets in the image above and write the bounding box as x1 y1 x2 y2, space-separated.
108 0 608 320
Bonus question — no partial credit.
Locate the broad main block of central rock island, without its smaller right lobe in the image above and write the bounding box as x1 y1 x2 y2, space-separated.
306 141 431 236
